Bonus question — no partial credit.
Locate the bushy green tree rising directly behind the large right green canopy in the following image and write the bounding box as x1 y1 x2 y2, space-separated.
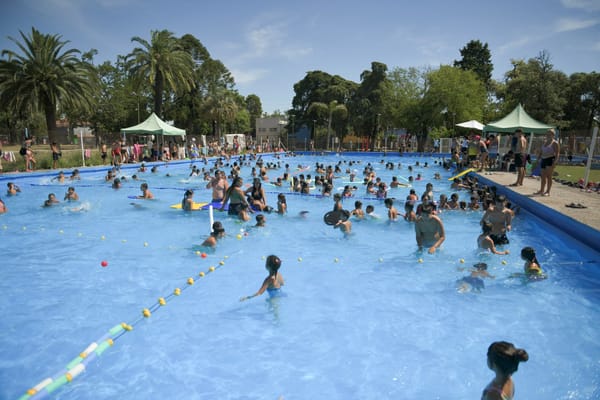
503 51 568 126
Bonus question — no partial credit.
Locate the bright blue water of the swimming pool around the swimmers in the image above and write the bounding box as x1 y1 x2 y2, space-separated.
0 155 600 400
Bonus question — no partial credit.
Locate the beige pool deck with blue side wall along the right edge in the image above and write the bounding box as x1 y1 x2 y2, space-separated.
477 171 600 250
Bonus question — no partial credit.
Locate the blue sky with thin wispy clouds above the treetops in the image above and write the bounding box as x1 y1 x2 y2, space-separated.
0 0 600 112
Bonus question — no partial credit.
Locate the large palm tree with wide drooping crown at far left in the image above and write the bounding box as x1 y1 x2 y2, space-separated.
0 28 95 142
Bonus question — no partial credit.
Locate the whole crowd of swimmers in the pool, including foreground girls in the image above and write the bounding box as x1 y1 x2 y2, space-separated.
0 152 545 399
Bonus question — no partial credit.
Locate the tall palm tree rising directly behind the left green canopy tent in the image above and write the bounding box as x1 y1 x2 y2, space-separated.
127 30 194 117
